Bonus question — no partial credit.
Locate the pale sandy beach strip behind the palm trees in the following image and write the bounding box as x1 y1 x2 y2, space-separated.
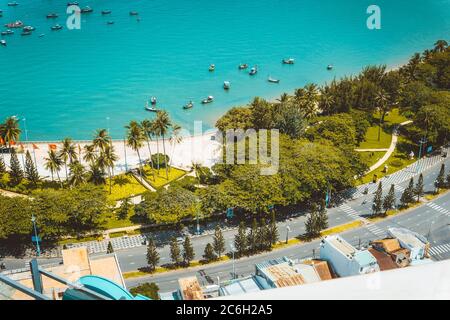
3 130 221 179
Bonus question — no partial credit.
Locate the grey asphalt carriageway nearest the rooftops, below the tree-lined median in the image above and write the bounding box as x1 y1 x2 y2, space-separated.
126 193 450 292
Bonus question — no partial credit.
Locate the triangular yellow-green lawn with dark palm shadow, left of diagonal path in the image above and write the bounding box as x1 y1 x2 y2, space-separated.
105 174 148 201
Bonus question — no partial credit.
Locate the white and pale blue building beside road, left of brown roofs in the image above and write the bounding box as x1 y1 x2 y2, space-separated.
320 235 380 277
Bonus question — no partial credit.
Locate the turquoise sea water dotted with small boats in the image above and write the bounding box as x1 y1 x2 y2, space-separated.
0 0 450 140
